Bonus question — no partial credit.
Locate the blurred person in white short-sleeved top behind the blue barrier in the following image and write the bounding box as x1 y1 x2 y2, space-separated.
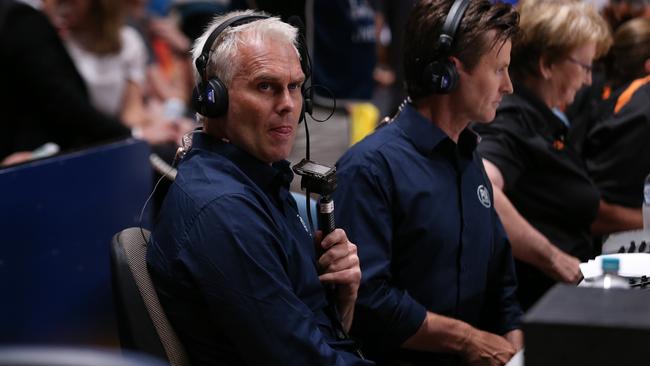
47 0 184 143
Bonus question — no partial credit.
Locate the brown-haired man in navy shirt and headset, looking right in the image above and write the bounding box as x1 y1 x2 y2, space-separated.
334 0 523 365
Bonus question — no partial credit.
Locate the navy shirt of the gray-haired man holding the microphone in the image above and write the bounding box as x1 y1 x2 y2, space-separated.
147 134 369 365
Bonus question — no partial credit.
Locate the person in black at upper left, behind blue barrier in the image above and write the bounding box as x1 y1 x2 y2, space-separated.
0 0 130 165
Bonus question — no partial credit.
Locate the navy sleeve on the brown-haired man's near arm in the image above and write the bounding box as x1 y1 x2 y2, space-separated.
334 158 426 347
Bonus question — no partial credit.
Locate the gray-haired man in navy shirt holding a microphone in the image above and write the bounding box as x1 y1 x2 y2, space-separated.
147 11 371 366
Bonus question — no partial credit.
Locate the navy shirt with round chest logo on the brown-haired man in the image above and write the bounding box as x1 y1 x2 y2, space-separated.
334 105 521 365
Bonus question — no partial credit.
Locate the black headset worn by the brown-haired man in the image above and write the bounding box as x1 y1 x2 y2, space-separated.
423 0 470 94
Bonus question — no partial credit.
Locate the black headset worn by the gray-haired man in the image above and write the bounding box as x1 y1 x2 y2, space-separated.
192 15 312 121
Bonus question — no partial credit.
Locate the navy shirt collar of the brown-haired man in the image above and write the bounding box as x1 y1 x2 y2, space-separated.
395 103 478 157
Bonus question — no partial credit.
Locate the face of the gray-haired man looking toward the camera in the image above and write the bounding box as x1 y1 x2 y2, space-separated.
225 39 305 163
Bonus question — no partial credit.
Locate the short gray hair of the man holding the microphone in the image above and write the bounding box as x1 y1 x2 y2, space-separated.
187 10 300 87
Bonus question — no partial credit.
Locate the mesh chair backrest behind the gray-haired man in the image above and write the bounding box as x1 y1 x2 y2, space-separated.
111 227 190 366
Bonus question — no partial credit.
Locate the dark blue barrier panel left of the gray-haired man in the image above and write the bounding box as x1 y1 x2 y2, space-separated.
0 139 152 345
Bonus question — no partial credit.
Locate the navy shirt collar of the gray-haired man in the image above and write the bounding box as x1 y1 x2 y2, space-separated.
192 133 293 193
